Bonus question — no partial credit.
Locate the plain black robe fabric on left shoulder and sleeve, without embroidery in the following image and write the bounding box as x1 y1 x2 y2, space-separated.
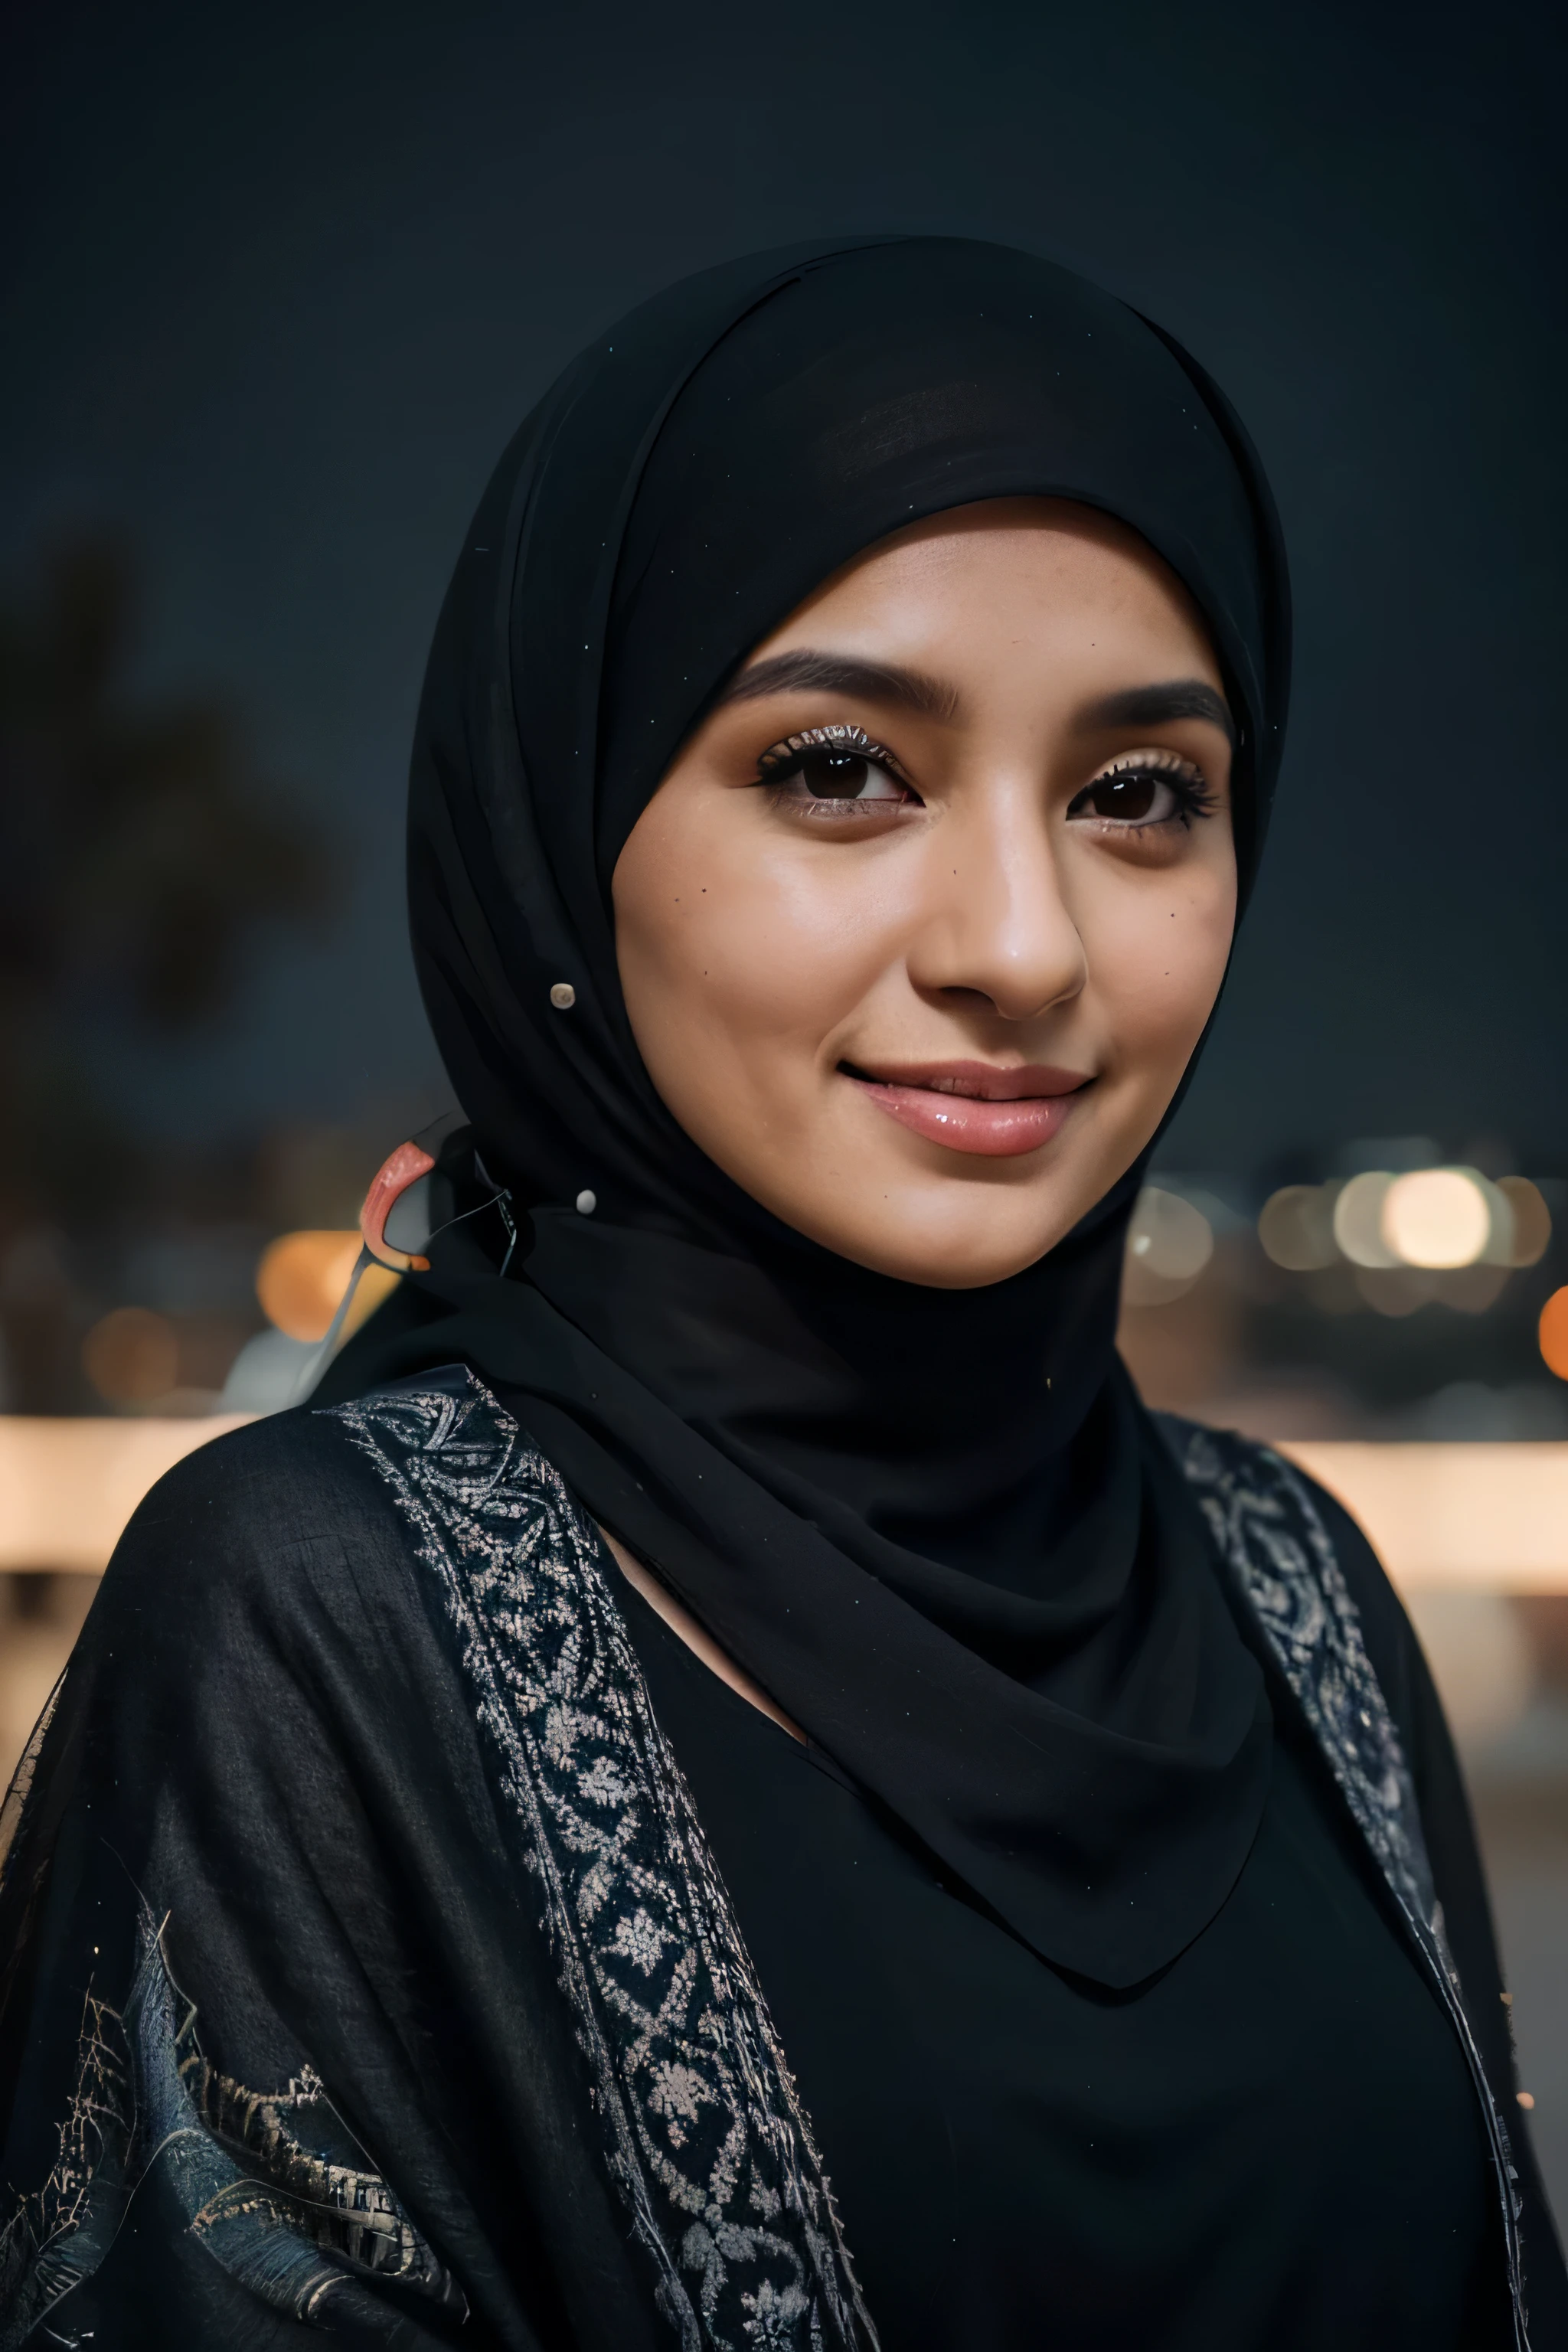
0 1413 644 2352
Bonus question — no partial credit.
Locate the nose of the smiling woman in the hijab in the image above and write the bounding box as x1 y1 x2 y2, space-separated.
907 779 1089 1021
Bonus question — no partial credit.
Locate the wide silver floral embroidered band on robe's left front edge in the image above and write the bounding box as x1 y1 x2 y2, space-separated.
332 1367 877 2352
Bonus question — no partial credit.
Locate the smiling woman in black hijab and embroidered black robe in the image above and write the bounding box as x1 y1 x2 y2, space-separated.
0 240 1568 2352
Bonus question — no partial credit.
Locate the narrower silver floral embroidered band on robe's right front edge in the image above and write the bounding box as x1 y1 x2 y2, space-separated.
1175 1413 1530 2352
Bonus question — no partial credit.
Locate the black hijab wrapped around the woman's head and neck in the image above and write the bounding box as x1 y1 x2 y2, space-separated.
322 237 1289 1985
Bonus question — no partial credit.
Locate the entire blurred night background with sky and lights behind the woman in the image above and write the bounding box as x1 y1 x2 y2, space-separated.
0 0 1568 2213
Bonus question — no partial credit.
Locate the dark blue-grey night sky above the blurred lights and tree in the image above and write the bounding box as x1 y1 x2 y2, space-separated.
0 0 1568 1167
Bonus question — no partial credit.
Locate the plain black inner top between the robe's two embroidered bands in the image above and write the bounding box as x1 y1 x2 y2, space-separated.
626 1561 1504 2352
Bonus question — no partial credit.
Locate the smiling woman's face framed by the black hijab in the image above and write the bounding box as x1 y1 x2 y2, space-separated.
613 498 1236 1289
